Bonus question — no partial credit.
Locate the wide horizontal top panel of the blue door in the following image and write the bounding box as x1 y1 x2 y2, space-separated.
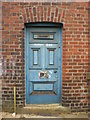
29 28 58 44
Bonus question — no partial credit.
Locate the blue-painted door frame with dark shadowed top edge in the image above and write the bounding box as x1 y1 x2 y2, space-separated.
24 22 63 105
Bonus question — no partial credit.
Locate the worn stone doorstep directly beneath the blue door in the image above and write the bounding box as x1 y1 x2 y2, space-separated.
17 104 71 116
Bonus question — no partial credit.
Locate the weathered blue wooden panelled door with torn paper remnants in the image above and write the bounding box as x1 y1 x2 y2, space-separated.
26 24 62 104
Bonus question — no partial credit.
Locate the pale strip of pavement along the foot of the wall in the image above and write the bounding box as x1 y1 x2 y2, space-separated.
1 112 89 119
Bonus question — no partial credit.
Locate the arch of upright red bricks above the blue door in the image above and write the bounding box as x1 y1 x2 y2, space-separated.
23 5 65 23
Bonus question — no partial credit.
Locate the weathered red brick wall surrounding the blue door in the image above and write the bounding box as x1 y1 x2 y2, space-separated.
2 2 88 111
